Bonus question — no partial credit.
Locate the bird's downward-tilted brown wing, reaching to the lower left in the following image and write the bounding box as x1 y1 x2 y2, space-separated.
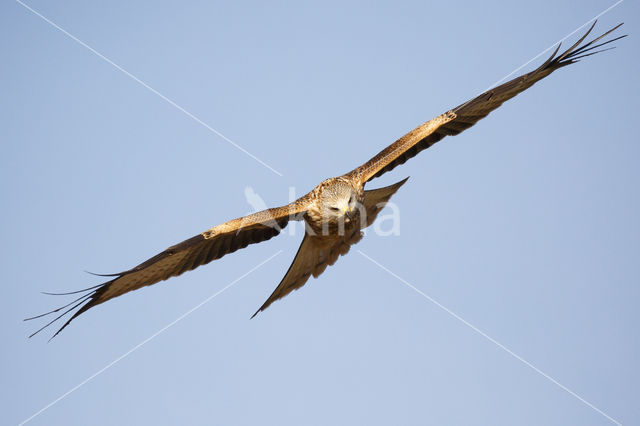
27 195 309 337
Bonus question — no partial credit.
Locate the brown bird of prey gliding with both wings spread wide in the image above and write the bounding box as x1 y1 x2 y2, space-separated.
27 22 626 338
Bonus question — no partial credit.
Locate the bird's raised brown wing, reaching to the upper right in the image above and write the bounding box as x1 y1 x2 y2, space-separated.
347 22 625 183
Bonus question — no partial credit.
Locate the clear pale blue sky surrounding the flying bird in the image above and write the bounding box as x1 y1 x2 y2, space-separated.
0 0 640 426
